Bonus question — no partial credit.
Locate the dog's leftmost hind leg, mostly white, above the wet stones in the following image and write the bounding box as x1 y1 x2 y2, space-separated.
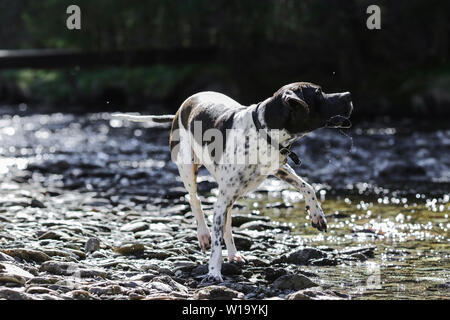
178 163 211 251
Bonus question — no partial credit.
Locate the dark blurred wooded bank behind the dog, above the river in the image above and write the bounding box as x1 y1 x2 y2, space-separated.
0 0 450 119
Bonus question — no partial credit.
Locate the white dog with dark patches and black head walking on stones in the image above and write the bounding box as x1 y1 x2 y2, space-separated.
113 82 353 283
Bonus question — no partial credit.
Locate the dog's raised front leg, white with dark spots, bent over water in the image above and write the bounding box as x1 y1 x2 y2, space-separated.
275 164 327 232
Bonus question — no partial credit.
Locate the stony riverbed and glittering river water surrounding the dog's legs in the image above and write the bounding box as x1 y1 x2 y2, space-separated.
0 110 450 299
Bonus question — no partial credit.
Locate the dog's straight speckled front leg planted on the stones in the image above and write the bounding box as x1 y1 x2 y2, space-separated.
202 190 233 284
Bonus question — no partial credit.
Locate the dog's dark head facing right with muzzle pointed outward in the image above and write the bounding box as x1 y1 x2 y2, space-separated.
264 82 353 135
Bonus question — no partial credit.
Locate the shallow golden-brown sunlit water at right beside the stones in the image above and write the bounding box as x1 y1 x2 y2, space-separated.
240 190 450 299
